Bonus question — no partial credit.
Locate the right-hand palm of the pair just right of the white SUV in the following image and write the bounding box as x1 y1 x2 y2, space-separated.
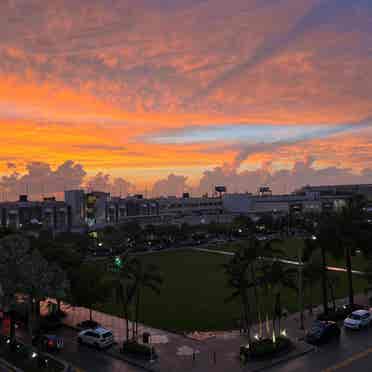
130 258 163 339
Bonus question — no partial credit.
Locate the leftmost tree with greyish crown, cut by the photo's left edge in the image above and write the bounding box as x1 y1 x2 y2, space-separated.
0 235 30 343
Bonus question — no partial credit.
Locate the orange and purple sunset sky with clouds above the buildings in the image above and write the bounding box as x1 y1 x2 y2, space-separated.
0 0 372 195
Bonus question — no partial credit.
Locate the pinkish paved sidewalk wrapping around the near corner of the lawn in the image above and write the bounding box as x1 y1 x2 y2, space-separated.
42 295 366 372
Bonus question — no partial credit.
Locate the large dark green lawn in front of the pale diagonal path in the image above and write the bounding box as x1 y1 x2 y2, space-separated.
98 251 367 331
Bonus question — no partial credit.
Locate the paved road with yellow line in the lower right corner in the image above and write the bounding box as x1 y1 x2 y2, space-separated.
272 328 372 372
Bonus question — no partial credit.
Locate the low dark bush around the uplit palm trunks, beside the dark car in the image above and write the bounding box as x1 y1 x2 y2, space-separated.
240 336 292 358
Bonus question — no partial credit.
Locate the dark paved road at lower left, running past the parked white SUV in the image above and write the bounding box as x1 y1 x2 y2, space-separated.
19 327 143 372
